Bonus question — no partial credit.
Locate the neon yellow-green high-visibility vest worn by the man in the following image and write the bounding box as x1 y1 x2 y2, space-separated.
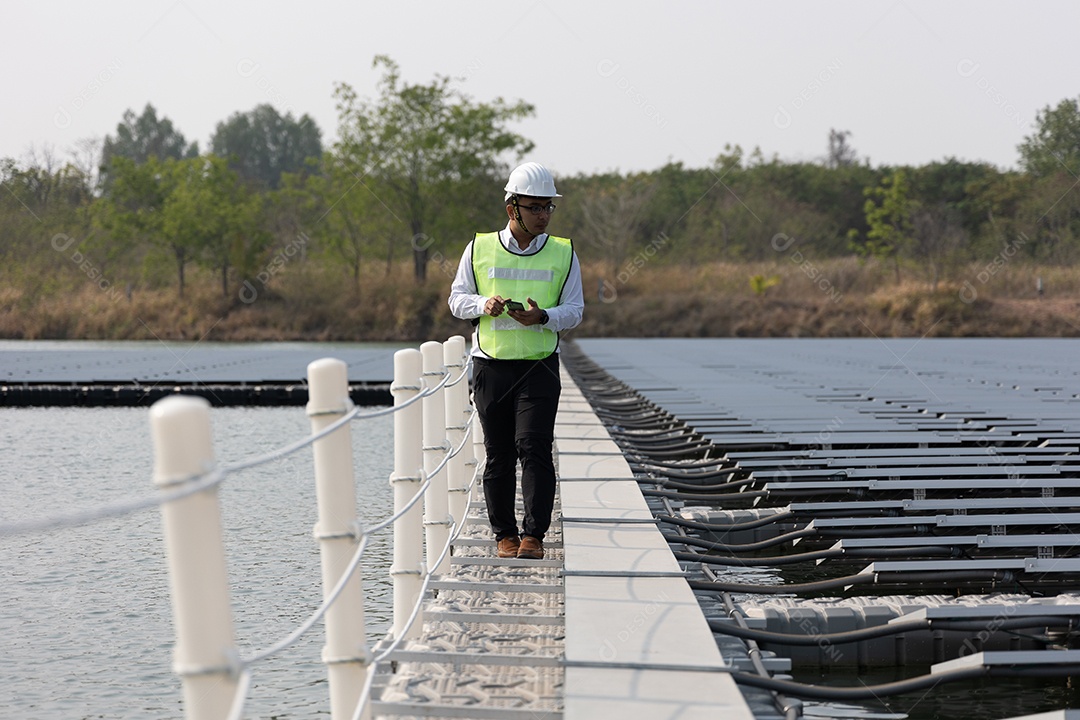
472 232 573 359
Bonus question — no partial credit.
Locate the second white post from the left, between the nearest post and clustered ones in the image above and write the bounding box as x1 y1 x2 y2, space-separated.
308 358 369 720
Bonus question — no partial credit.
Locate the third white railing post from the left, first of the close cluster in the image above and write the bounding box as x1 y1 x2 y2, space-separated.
390 349 424 639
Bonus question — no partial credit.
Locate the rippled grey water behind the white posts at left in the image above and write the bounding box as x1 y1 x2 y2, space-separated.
0 408 393 720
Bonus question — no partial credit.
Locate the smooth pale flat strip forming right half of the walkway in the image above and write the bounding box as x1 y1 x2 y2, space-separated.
555 369 754 720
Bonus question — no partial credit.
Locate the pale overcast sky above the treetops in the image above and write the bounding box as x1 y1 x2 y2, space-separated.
0 0 1080 175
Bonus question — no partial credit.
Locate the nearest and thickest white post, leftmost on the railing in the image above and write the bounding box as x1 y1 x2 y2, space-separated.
150 395 238 720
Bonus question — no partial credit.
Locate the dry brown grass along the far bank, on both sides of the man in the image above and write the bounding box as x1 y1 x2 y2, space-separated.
6 257 1080 342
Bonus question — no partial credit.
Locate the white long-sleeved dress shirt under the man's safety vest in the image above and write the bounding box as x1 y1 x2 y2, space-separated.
447 222 585 357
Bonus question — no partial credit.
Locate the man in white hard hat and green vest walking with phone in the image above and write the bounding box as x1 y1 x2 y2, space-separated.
449 163 585 559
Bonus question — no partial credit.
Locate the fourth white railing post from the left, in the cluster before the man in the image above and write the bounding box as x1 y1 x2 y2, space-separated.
420 340 450 574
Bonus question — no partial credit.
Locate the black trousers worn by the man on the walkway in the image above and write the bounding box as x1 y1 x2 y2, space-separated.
473 353 563 540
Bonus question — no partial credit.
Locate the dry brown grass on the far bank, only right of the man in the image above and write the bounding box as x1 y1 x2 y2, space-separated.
578 257 1080 337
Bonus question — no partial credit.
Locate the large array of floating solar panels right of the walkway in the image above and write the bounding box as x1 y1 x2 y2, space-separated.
579 339 1080 592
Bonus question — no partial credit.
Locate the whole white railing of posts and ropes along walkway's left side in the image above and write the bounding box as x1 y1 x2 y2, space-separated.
0 336 483 720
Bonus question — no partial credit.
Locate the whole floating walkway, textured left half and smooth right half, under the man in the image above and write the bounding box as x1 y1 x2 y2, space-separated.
373 362 755 720
